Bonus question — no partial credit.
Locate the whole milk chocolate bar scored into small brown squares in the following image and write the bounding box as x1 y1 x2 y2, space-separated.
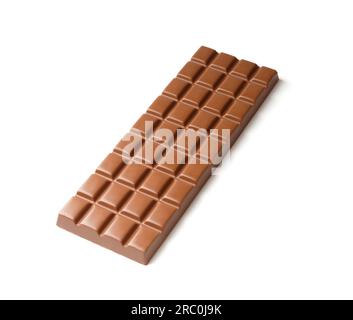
57 47 278 264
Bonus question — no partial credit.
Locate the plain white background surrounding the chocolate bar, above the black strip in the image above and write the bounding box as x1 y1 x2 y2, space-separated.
0 0 353 299
